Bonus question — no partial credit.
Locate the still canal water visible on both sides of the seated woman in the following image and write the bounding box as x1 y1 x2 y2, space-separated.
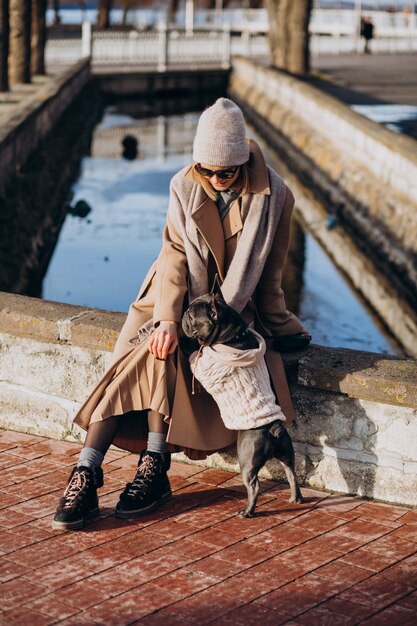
42 103 400 354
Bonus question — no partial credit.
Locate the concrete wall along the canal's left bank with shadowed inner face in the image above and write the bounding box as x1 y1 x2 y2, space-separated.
0 59 90 194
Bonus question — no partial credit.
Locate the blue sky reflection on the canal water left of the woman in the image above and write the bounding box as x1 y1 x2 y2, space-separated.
43 155 188 311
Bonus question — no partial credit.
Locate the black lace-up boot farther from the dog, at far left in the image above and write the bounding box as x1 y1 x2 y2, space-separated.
52 467 103 530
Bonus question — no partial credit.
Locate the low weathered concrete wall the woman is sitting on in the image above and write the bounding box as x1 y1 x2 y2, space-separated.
0 293 417 505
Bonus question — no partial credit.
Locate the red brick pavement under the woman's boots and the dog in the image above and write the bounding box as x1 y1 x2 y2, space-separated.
0 431 417 626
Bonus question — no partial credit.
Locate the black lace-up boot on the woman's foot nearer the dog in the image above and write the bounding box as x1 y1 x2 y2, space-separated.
116 450 171 518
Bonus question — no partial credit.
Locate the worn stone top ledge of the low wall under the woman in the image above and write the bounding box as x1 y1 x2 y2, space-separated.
0 292 417 408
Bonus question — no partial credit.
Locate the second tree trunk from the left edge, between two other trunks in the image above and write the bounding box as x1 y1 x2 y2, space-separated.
9 0 32 85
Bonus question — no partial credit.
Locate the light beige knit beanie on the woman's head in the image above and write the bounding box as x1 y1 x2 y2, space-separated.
193 98 249 166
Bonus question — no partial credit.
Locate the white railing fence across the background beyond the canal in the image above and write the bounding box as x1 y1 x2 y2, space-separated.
46 9 417 71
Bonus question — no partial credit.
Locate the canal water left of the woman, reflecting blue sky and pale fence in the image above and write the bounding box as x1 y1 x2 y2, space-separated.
43 107 199 311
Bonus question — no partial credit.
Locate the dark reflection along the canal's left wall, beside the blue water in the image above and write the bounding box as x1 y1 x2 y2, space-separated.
0 81 102 297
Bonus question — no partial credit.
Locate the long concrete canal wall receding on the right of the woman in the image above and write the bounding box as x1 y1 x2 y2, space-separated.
229 58 417 355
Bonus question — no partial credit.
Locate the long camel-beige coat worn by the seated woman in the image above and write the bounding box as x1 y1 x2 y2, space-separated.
75 139 303 458
